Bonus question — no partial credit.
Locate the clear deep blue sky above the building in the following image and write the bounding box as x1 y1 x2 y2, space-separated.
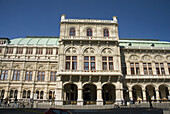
0 0 170 41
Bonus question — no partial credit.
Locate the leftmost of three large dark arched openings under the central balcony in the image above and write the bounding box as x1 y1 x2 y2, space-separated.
64 84 77 104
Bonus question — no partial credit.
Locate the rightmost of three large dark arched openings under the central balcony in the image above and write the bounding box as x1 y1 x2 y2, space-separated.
102 84 116 104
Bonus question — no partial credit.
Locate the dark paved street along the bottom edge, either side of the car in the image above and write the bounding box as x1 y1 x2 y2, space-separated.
0 108 163 114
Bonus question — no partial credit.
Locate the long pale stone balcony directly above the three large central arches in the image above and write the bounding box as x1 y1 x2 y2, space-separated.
59 70 122 76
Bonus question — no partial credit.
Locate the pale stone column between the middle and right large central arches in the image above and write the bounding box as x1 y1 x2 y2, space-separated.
96 82 103 105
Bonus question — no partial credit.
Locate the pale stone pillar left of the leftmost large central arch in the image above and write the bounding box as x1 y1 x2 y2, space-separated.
55 76 63 105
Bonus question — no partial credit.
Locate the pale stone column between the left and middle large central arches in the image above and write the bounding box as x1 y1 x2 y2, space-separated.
77 82 83 105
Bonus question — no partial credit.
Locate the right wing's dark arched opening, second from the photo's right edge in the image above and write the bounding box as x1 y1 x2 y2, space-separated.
145 85 156 102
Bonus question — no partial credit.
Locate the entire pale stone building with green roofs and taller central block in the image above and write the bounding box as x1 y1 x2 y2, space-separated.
0 15 170 105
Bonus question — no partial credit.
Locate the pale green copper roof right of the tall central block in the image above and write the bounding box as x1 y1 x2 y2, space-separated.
119 39 170 47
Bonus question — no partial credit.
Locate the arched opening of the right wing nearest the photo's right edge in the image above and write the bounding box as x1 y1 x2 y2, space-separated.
159 85 169 99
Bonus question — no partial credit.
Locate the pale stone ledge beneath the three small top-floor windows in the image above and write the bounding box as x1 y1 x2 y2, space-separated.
62 36 118 41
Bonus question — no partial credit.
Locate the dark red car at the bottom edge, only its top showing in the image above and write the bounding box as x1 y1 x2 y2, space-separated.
44 108 71 114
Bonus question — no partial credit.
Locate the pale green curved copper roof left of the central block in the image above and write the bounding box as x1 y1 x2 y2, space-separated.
10 37 59 45
